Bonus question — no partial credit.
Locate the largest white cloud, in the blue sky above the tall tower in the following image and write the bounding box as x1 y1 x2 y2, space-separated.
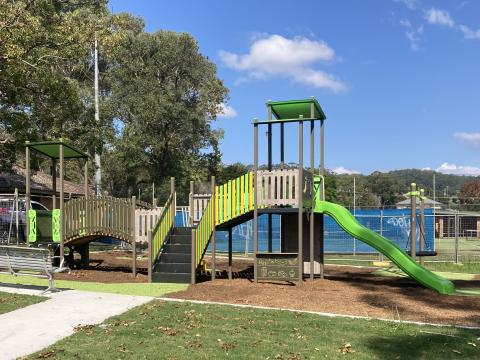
219 34 346 92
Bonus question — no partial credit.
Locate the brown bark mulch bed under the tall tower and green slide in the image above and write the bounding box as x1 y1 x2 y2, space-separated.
168 259 480 326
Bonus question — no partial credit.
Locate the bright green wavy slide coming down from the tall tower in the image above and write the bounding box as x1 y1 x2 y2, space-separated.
315 200 455 294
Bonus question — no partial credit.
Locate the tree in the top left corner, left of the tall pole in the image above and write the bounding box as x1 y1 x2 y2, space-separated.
0 0 106 146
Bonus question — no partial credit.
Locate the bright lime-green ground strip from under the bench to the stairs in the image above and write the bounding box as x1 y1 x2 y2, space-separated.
0 274 187 296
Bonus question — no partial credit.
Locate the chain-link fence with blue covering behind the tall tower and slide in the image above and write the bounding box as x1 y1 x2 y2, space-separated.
202 208 480 266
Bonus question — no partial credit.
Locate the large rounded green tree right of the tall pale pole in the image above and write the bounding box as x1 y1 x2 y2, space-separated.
100 28 228 198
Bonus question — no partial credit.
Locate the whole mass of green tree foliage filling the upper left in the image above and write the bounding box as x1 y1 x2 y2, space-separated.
0 0 228 202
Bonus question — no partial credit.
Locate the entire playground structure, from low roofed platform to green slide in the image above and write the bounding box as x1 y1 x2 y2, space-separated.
22 98 454 294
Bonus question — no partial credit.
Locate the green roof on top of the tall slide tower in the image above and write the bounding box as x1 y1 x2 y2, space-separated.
267 97 327 120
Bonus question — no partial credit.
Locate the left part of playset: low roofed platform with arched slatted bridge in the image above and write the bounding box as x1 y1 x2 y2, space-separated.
25 140 151 274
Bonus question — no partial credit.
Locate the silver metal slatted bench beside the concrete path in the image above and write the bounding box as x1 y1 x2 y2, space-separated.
0 246 68 293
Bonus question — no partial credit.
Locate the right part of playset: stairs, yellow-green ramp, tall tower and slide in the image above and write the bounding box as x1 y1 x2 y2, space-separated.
149 98 454 294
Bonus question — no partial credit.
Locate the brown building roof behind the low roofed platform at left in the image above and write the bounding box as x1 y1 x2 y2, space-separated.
0 165 94 195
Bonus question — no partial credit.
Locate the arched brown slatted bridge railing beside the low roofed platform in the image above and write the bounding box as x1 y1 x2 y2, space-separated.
64 196 135 243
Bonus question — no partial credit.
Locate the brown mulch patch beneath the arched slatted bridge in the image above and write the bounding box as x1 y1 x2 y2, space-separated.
55 251 148 283
